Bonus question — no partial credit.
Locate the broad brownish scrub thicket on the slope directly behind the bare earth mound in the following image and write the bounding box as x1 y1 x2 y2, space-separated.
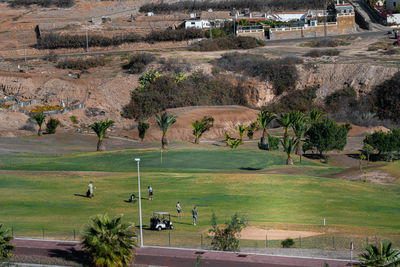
122 72 258 119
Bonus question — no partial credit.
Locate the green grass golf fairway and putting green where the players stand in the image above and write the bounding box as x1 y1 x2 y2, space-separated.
0 149 400 249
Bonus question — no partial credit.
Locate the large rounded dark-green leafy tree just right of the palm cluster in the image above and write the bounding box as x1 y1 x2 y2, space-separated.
306 118 349 160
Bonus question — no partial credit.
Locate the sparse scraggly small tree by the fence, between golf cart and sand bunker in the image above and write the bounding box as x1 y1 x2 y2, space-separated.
209 213 247 251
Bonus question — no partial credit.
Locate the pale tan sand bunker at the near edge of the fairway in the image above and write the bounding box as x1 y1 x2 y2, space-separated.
240 227 321 240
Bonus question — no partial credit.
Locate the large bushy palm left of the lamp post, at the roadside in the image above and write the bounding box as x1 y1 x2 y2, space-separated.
82 215 137 267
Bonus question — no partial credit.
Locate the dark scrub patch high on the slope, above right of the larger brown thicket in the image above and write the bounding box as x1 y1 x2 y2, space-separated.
214 52 298 95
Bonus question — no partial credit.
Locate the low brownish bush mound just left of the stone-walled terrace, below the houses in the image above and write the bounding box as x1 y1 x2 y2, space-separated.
190 36 264 51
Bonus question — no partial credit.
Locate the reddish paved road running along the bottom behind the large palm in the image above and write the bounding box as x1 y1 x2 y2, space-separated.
13 239 350 267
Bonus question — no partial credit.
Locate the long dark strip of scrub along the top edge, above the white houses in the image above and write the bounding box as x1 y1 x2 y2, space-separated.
139 0 324 13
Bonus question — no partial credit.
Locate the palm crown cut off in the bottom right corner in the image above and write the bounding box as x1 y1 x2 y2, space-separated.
359 242 400 267
